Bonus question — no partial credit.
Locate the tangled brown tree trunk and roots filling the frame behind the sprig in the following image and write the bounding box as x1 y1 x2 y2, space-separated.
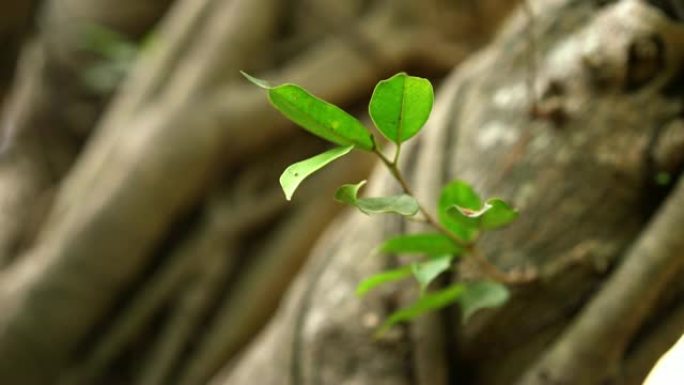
0 0 684 385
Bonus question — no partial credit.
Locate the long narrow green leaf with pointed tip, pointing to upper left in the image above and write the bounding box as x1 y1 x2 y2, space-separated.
242 72 375 151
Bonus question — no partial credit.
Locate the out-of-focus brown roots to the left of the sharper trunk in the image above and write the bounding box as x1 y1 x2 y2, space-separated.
0 0 684 385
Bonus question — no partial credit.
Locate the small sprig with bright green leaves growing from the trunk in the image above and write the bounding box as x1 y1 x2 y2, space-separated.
243 72 518 333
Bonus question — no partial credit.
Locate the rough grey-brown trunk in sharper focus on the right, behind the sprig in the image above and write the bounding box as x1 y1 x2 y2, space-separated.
222 0 684 385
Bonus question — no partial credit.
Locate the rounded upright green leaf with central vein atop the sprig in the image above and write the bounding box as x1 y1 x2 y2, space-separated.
369 73 434 144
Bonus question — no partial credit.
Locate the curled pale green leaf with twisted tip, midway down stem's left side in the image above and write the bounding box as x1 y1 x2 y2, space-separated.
335 181 419 216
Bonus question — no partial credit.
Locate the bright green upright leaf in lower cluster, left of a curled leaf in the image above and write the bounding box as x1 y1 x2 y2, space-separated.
437 180 482 242
